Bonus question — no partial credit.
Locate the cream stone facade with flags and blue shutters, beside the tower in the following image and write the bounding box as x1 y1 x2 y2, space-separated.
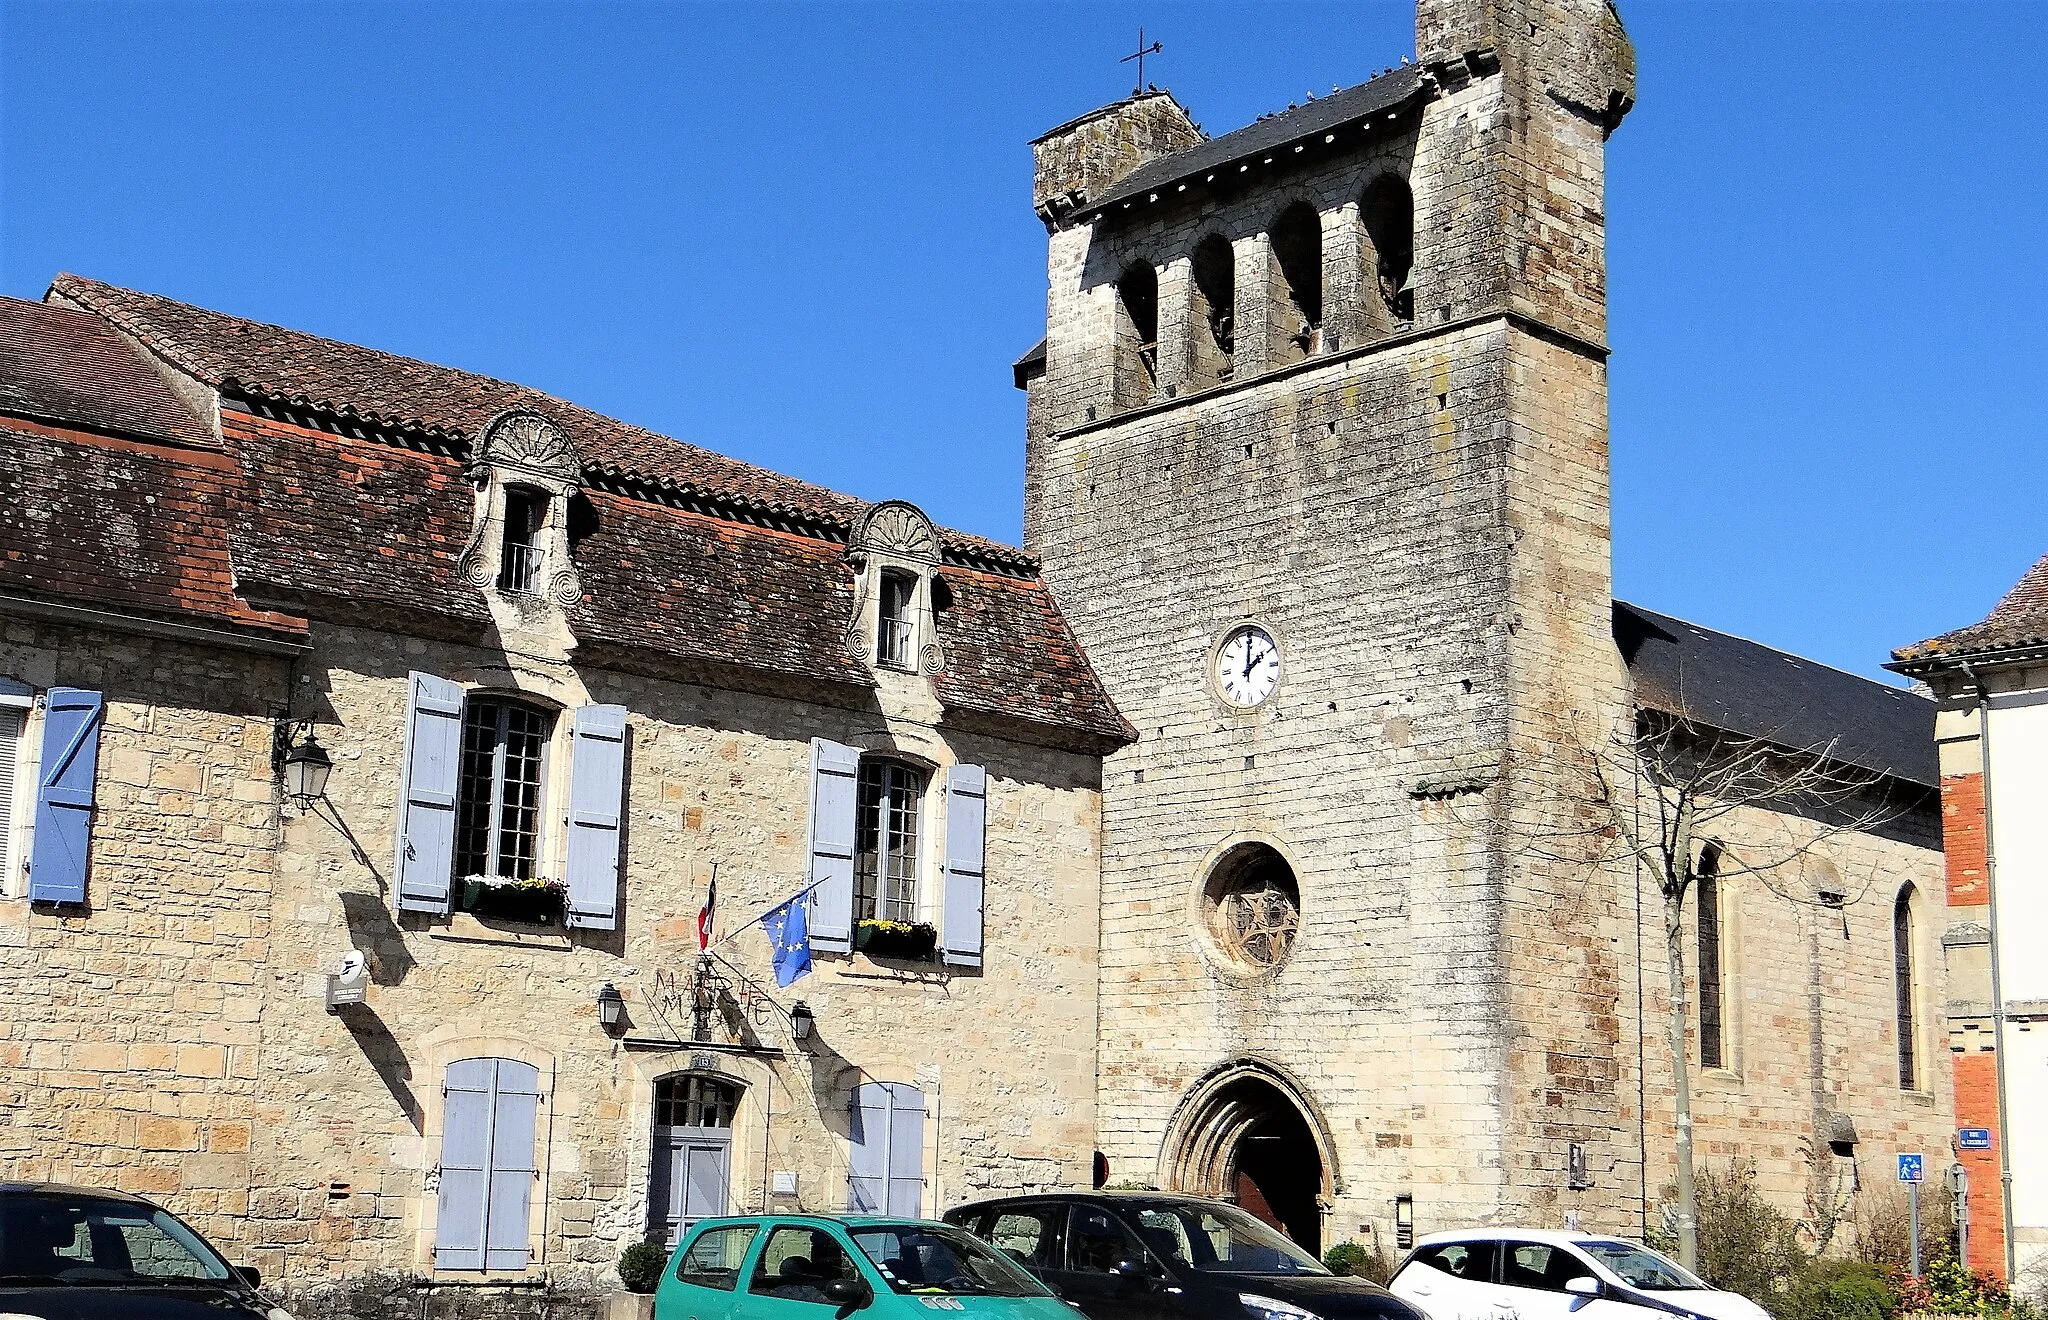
250 628 1098 1281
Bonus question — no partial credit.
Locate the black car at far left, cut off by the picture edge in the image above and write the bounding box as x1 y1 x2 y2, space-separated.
0 1183 291 1320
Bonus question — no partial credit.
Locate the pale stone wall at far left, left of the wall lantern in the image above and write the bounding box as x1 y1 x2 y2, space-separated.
0 620 285 1257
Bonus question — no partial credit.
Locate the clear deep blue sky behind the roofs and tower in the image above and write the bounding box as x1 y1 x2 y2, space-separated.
0 0 2048 673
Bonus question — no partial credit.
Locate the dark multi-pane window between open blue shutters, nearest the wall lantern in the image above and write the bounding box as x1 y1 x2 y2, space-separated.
455 698 555 880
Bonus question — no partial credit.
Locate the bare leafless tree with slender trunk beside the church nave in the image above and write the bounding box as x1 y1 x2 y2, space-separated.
1532 710 1903 1269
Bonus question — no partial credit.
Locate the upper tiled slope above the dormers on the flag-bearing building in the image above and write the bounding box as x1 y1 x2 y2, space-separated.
49 274 1034 567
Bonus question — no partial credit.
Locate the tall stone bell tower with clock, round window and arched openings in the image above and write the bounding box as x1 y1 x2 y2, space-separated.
1018 0 1640 1252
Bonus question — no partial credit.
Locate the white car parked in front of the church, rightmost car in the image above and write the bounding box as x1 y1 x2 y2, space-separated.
1389 1228 1772 1320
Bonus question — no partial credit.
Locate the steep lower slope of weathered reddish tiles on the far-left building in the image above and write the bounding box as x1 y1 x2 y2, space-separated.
0 409 305 641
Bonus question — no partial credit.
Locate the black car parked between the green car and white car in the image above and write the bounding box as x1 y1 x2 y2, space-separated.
946 1191 1423 1320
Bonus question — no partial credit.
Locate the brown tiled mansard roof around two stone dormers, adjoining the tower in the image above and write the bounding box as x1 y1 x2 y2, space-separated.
24 276 1135 751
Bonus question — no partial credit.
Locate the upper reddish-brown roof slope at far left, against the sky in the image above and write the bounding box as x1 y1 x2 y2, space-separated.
0 299 215 448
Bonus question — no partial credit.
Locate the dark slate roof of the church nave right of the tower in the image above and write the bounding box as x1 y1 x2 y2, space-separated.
1614 600 1939 788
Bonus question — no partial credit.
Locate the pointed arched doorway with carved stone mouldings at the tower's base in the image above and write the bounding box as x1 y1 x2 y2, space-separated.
1159 1060 1335 1257
